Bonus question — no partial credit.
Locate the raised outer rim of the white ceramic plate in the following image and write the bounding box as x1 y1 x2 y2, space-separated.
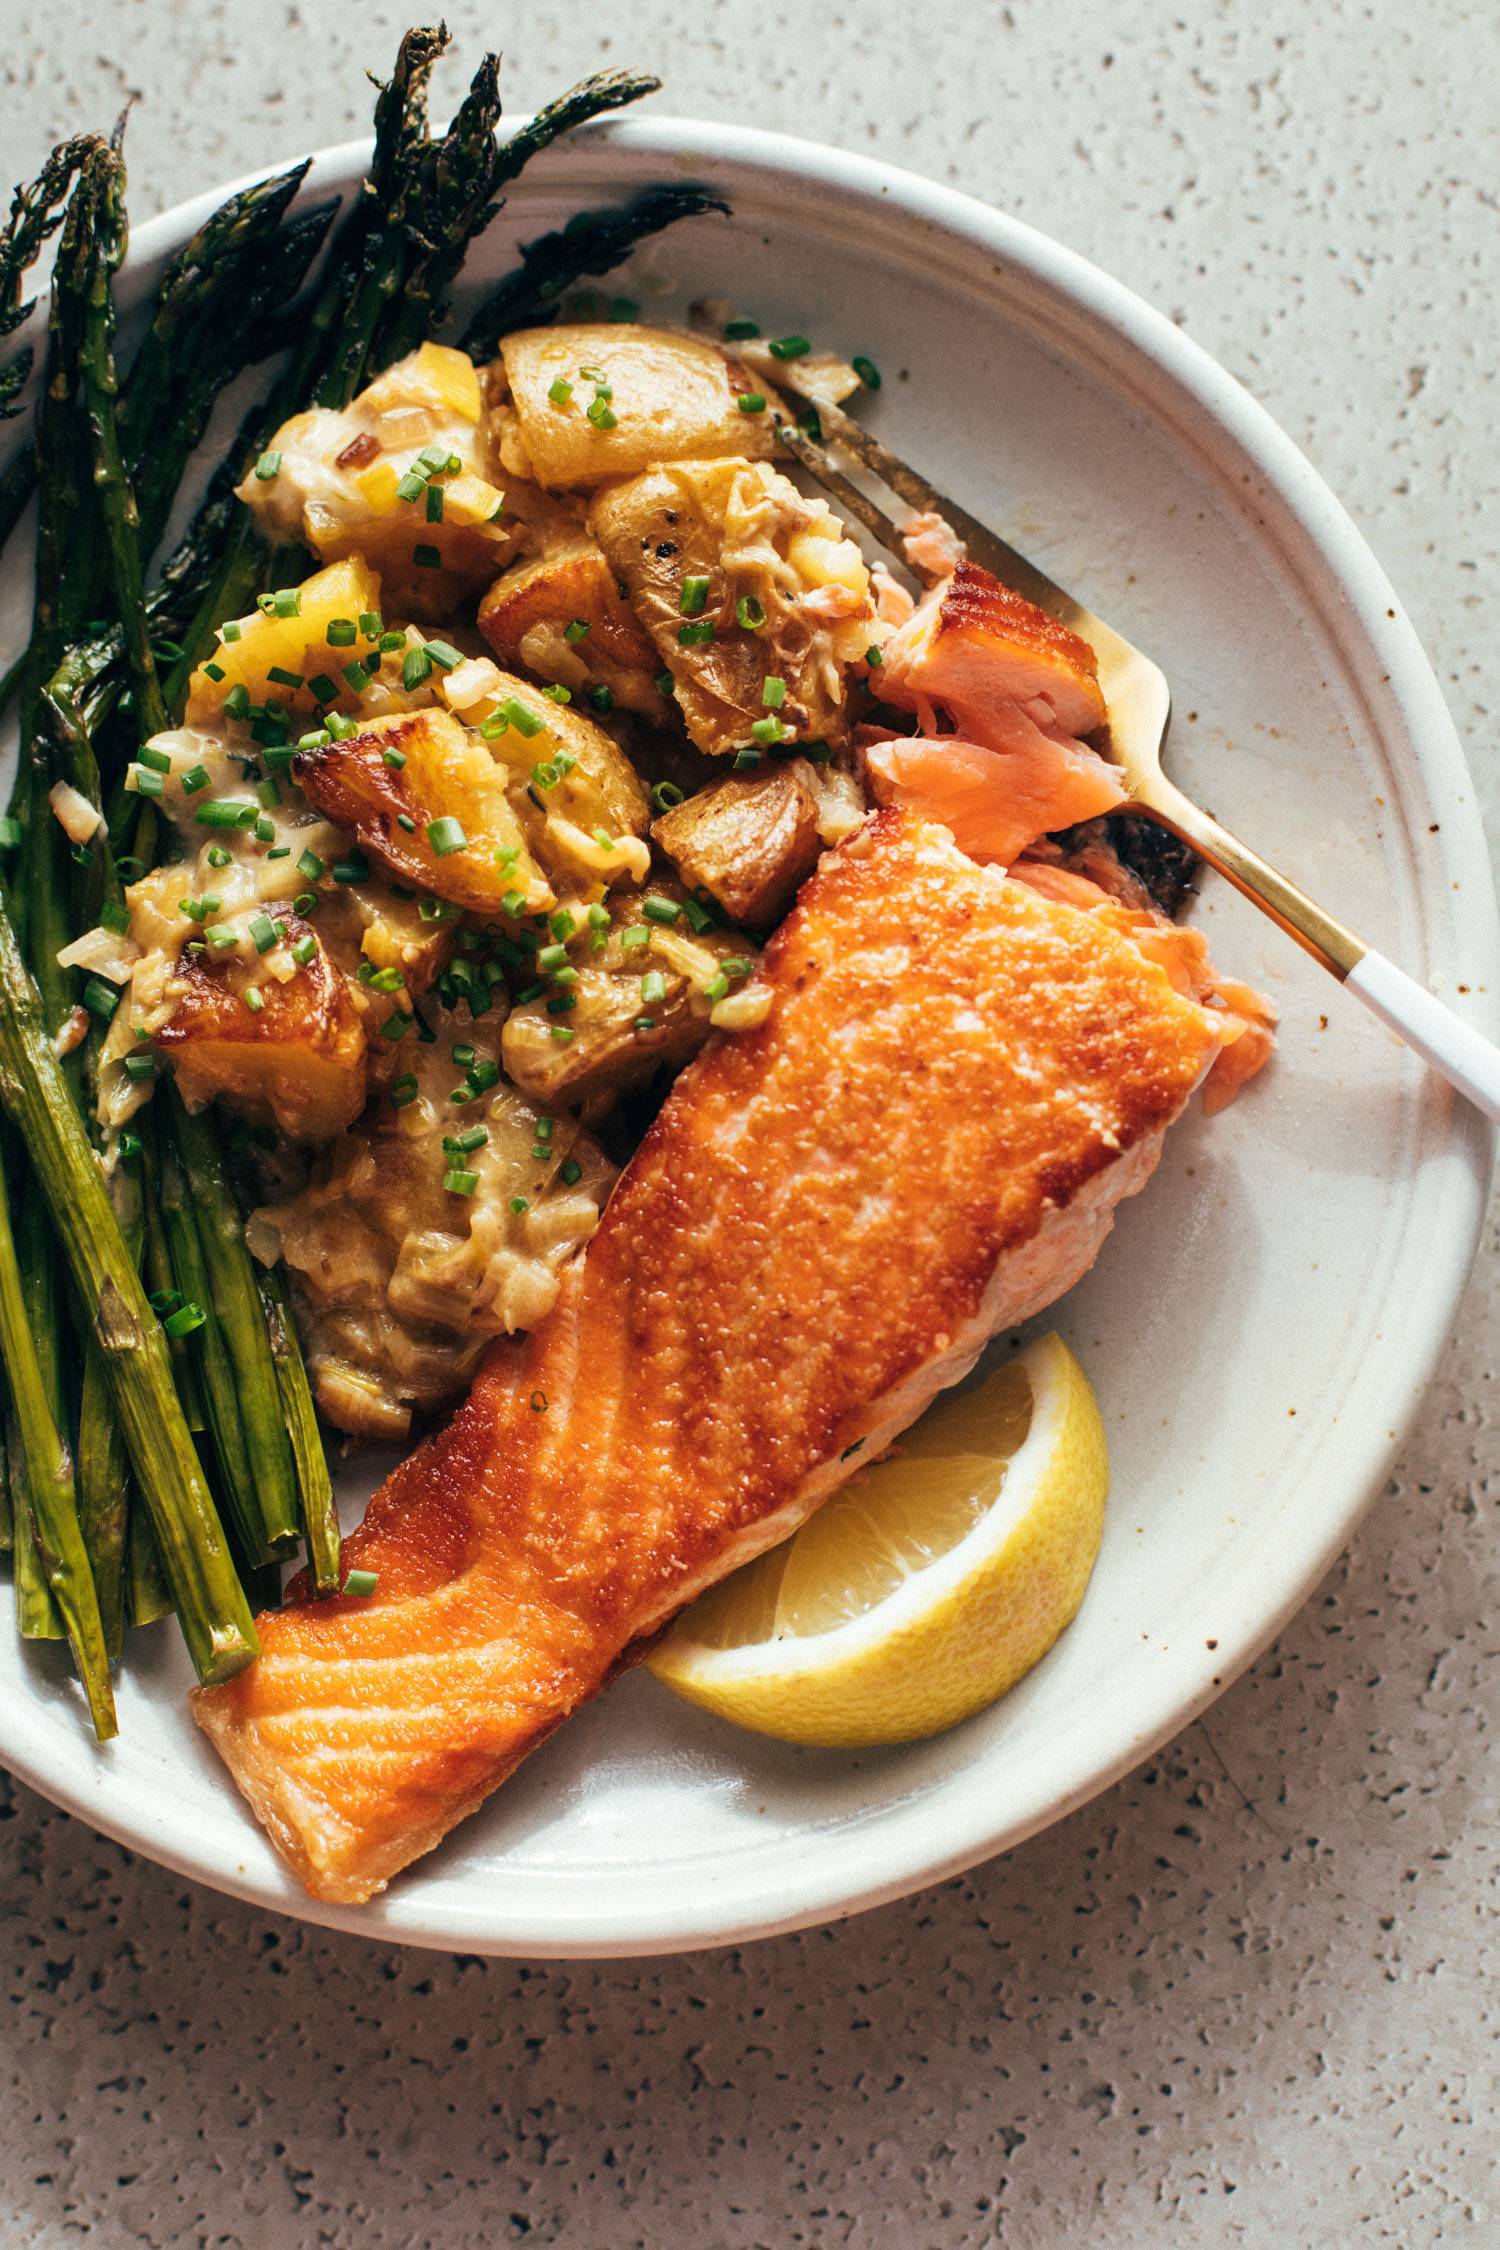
0 115 1500 1960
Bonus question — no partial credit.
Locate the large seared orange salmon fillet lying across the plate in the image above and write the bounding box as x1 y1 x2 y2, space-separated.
193 812 1219 1901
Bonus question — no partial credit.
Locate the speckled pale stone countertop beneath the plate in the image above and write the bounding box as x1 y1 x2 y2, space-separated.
0 0 1500 2250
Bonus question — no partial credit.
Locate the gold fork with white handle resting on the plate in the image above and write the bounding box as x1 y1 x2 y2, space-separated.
776 391 1500 1123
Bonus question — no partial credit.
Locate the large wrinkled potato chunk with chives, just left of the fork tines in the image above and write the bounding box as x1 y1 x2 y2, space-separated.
589 461 875 756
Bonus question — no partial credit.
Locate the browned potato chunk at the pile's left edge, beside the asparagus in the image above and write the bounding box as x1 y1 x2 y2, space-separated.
153 911 369 1141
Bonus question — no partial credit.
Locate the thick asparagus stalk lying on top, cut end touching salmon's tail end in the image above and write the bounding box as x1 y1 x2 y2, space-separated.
0 902 259 1681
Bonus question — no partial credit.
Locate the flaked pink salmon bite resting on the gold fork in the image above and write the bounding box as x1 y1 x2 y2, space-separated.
866 560 1124 866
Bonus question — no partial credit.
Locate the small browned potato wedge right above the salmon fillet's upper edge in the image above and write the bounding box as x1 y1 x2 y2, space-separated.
652 758 821 929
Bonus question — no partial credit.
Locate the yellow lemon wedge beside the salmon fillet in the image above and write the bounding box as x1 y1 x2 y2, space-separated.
648 1337 1109 1748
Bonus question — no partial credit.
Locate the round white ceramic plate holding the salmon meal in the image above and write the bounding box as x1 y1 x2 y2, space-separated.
0 119 1500 1955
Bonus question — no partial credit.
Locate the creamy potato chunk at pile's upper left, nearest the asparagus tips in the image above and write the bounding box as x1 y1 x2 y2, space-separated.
238 344 513 617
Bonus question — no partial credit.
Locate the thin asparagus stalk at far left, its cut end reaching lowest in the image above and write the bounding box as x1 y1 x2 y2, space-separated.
0 1125 117 1742
